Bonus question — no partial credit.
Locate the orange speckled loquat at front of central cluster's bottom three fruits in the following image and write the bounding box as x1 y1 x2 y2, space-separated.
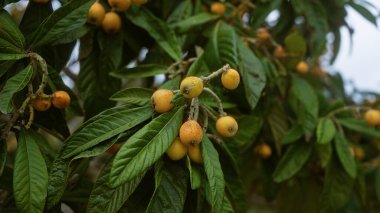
179 120 203 145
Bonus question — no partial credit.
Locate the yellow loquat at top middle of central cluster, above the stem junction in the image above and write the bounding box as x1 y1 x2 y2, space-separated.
179 76 203 98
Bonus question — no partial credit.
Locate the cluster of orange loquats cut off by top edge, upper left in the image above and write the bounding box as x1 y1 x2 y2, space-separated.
87 0 147 34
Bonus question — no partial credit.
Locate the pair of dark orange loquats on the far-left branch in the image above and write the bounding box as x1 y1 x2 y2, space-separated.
31 91 70 112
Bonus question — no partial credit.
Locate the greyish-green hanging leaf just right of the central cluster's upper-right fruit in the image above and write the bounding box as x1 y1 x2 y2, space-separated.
237 39 266 110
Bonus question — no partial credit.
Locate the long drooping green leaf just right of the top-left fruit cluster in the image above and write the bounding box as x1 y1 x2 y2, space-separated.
125 7 182 61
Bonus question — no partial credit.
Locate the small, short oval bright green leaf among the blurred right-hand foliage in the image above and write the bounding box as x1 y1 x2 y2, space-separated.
317 118 336 144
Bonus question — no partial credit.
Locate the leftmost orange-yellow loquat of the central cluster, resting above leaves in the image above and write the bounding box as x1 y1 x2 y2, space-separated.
151 89 174 113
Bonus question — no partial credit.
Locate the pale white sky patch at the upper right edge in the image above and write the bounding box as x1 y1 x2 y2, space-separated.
333 0 380 93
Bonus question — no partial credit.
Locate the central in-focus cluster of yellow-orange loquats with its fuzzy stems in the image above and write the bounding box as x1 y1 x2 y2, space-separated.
151 65 240 163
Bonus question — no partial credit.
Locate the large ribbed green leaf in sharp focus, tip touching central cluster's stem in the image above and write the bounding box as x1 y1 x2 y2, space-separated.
109 107 184 187
